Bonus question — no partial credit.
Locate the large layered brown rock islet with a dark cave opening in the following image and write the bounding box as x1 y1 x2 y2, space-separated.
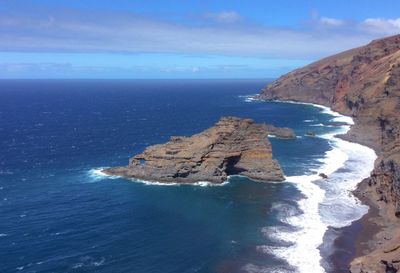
104 117 284 183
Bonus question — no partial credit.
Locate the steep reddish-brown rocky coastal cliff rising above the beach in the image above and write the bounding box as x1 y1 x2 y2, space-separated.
260 35 400 273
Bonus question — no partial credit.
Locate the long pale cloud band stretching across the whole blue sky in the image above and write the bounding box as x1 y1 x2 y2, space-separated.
0 10 399 59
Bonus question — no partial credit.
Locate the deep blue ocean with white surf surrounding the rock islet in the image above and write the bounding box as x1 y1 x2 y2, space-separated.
0 80 375 273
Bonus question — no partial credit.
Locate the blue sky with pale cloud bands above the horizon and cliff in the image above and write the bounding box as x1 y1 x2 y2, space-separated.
0 0 400 79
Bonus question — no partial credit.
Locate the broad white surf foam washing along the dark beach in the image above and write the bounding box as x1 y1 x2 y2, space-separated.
262 101 376 273
